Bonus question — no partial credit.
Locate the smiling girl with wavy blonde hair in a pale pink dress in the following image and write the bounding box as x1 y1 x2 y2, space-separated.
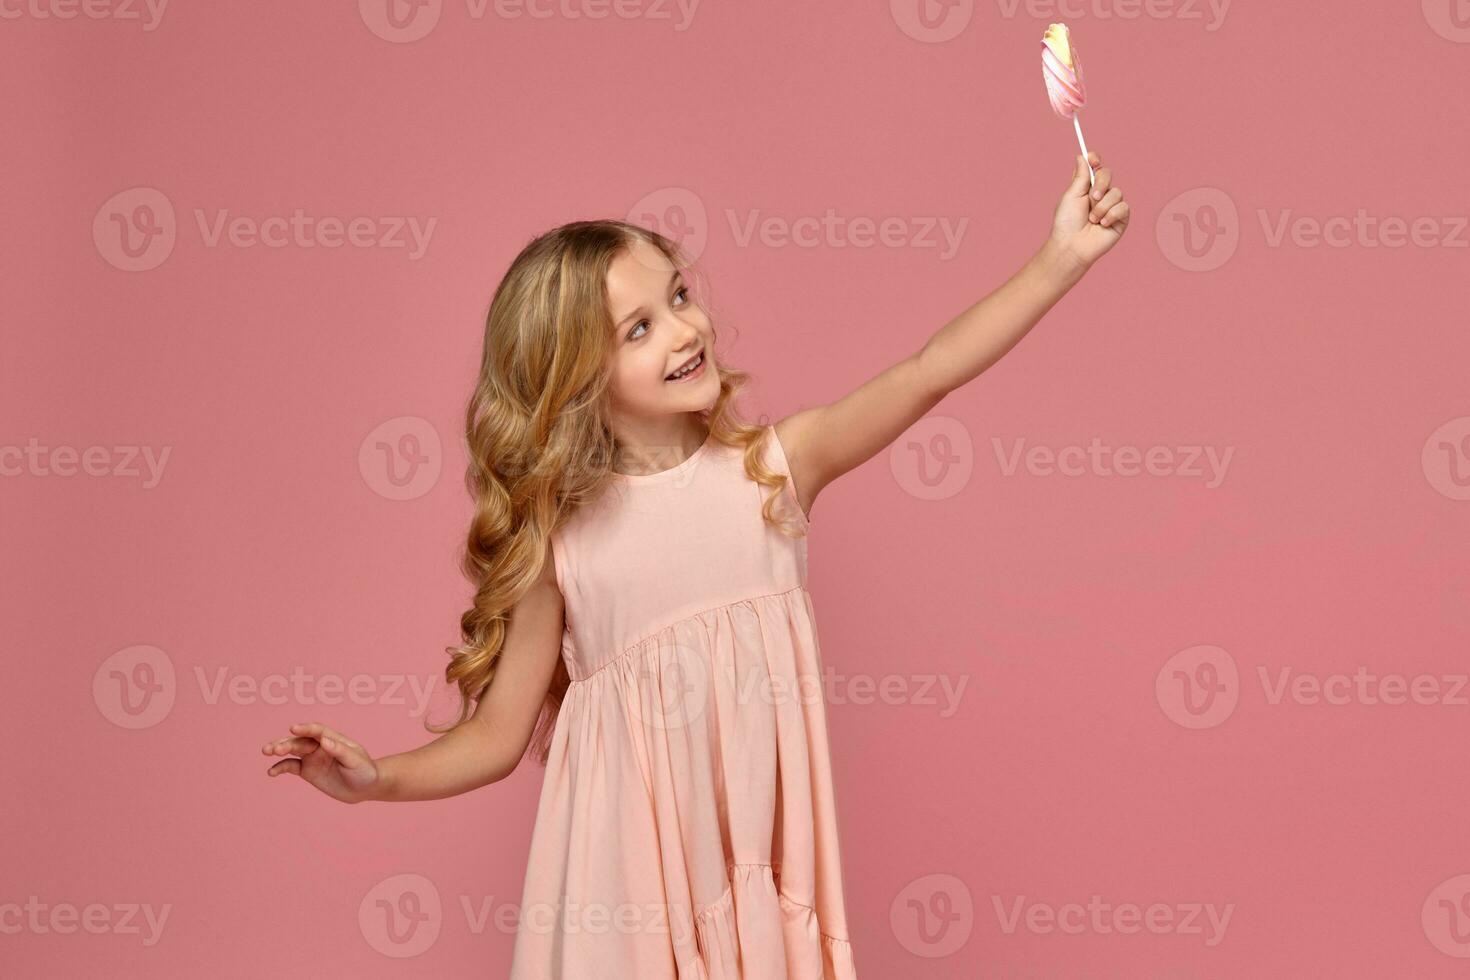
263 153 1129 980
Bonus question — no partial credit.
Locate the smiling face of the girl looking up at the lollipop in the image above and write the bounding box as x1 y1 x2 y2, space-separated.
607 239 720 420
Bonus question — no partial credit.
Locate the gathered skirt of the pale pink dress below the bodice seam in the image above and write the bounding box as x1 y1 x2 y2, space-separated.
512 586 857 980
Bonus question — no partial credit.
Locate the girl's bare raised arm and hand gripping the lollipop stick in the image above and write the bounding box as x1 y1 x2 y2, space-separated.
776 153 1129 513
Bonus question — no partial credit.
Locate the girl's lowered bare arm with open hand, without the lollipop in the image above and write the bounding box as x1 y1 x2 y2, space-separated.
262 545 566 804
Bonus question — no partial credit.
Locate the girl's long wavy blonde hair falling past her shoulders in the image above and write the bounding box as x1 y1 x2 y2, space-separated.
425 219 804 765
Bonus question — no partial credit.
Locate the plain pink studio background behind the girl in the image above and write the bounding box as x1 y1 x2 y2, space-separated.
0 0 1470 980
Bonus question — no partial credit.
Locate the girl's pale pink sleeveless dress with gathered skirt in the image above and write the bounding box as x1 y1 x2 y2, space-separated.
510 426 857 980
